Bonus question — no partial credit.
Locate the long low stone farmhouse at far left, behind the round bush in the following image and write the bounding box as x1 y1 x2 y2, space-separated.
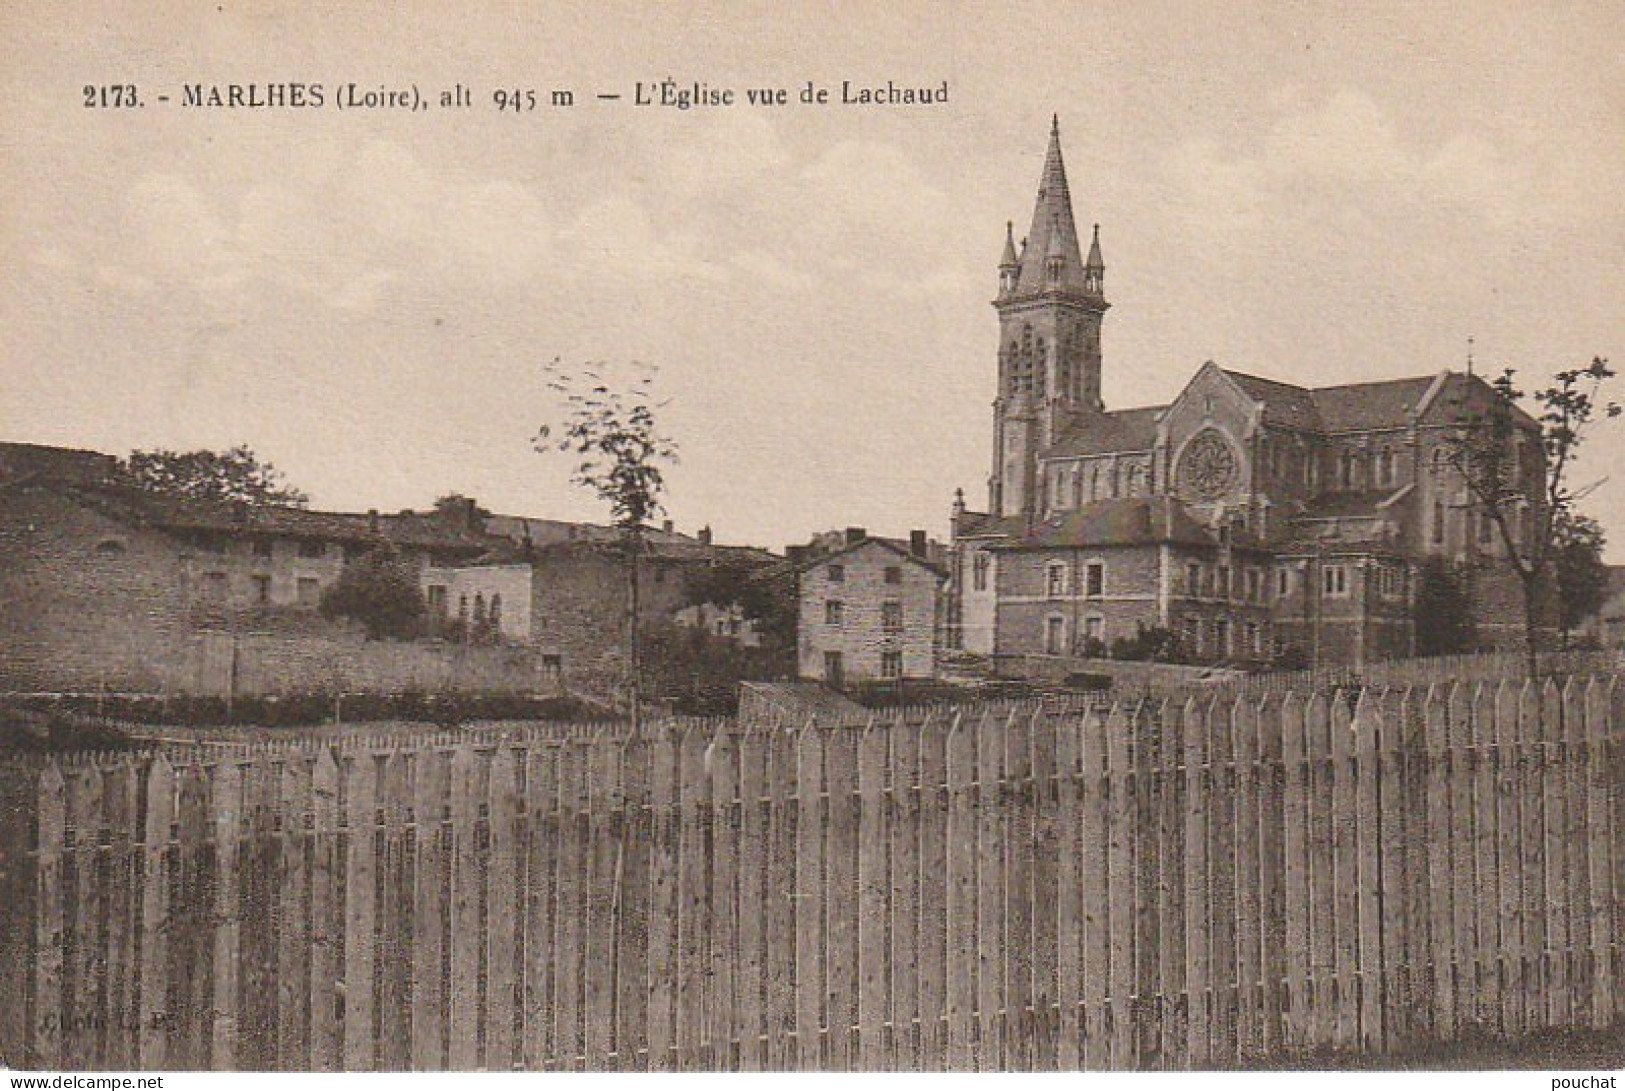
0 444 531 688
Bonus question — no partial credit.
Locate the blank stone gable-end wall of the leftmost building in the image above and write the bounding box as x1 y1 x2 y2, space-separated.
0 486 189 689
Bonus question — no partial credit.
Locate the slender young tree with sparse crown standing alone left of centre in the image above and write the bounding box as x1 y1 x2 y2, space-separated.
533 359 678 735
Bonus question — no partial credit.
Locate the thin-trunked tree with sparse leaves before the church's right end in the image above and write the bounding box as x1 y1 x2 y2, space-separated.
1445 356 1620 675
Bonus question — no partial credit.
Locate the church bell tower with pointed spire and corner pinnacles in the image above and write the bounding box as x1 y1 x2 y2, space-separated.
988 119 1110 515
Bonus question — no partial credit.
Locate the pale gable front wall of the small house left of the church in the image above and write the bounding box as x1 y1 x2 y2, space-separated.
796 545 939 681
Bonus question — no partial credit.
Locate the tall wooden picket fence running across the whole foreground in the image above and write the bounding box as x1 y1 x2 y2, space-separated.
0 676 1625 1070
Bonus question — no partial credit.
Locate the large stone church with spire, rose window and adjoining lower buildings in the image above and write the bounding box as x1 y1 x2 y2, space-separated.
944 124 1545 665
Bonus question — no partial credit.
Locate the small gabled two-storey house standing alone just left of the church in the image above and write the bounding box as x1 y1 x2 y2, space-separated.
796 527 946 686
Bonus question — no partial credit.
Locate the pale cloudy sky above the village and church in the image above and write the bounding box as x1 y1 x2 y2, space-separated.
0 0 1625 561
